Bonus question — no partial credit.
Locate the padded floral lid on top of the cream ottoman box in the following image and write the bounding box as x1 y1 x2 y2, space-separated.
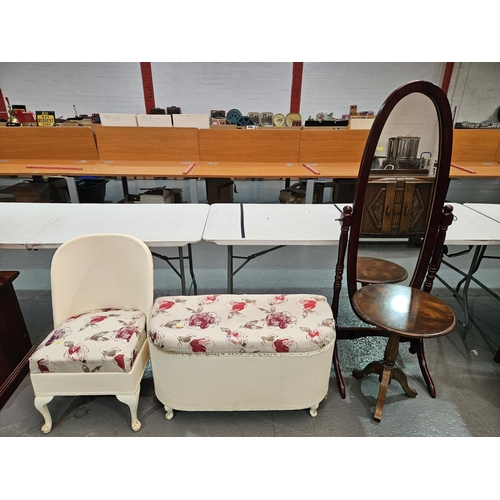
148 294 335 354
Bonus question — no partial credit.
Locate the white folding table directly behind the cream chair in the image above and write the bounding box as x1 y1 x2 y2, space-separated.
0 203 209 294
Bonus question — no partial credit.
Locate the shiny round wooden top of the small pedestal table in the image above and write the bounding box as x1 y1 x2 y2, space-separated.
352 284 456 338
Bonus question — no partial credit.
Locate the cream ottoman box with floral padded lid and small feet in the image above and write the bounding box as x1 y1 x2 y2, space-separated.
148 294 335 420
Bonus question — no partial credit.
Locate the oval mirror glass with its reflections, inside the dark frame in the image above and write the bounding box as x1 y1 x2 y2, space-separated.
356 93 439 290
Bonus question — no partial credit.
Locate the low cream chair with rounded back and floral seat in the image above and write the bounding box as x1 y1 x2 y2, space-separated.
29 234 153 433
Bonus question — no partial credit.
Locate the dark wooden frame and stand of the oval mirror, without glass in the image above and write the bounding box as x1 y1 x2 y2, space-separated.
332 81 453 398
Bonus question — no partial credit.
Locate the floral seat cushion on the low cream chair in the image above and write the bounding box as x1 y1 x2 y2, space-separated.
29 308 146 373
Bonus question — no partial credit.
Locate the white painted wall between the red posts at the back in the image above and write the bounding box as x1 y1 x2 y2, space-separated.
0 62 500 121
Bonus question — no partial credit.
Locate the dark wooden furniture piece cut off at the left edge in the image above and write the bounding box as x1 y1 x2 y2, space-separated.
0 271 35 408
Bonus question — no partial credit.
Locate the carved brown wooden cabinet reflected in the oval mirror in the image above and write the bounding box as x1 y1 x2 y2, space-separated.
361 177 434 238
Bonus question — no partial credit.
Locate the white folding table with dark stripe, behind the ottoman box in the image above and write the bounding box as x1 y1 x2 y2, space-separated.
203 203 340 293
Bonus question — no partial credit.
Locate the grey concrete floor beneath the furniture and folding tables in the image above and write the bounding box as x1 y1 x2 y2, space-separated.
0 181 500 443
